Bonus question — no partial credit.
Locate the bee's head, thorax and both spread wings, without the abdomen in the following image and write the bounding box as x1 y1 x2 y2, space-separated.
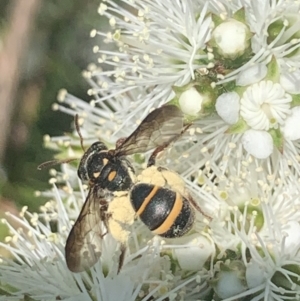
65 105 188 272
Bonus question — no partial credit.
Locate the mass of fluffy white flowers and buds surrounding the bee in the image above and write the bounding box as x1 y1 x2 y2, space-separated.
0 0 300 301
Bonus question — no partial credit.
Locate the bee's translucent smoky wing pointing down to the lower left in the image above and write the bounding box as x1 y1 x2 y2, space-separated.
65 186 107 273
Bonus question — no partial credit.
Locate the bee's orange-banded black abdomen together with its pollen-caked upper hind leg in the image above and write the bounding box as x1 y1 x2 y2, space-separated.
130 138 211 238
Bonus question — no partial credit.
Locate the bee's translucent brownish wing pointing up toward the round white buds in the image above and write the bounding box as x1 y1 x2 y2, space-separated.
115 105 183 156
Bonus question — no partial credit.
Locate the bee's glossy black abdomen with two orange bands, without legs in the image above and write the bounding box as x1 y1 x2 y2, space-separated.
130 183 194 238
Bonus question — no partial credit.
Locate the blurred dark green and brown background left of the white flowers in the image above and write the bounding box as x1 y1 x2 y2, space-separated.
0 0 103 230
